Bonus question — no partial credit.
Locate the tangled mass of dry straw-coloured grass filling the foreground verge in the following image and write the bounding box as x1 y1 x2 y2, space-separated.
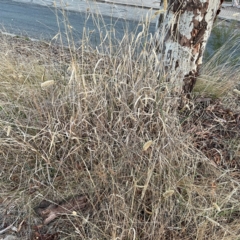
0 15 240 240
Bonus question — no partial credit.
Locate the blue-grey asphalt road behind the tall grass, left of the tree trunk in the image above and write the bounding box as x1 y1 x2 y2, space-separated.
0 0 155 46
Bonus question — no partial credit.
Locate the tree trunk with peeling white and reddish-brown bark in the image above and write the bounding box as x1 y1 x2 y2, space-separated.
154 0 223 93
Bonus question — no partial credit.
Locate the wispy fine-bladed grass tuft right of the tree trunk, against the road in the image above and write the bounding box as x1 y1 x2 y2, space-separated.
194 30 240 100
